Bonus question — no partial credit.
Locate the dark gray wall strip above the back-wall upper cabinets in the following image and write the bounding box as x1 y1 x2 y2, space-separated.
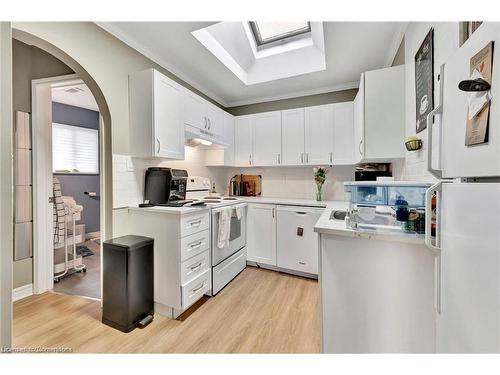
226 89 358 116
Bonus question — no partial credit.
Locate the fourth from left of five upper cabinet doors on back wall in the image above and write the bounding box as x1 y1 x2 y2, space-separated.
305 104 333 164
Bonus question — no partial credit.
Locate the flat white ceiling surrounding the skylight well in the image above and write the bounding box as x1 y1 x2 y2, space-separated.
98 22 406 107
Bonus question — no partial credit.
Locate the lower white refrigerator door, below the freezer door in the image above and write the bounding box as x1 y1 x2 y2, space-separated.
436 183 500 353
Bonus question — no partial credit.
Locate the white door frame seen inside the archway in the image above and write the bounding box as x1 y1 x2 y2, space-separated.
31 74 104 294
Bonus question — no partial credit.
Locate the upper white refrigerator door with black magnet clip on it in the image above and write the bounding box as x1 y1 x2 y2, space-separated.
442 22 500 178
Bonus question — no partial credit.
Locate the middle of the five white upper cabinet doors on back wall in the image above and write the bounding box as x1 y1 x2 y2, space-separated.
281 108 304 165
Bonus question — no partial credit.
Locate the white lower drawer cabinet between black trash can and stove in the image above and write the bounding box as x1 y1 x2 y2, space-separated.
126 208 212 318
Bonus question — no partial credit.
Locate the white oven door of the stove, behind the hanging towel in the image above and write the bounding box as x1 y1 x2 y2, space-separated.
212 203 247 266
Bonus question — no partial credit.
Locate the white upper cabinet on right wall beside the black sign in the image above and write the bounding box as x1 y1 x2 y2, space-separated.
358 65 405 161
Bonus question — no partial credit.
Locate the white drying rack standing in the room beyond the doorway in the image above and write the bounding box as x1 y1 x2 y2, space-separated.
54 212 87 283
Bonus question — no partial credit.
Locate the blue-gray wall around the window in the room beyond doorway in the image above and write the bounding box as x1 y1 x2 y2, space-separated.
52 103 101 233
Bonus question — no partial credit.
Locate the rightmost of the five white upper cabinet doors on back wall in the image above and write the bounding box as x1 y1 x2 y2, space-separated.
333 102 356 165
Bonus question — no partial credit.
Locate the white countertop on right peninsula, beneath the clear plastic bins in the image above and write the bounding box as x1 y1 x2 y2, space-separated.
314 201 424 244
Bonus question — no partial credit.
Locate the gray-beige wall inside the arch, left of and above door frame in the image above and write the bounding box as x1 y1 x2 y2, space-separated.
12 39 73 288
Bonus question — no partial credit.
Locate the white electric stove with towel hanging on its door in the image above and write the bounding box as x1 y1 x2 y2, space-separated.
186 176 247 296
